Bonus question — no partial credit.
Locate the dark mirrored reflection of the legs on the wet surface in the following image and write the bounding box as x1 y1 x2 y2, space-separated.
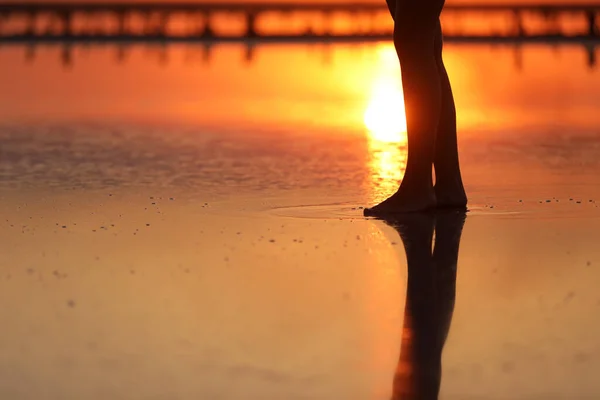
386 212 466 400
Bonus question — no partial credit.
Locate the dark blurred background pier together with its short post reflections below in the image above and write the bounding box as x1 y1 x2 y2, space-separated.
0 0 600 66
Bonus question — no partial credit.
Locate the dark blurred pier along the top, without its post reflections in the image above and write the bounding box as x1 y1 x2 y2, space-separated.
0 0 600 43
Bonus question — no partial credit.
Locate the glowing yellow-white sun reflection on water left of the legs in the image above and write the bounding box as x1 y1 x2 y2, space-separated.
364 45 408 201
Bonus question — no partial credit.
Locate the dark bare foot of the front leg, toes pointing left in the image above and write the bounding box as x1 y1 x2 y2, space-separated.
364 186 436 217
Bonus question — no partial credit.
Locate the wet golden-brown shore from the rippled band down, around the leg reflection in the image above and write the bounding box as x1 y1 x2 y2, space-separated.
0 119 600 399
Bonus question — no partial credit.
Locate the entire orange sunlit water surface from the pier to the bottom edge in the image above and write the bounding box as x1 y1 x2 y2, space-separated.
0 44 600 400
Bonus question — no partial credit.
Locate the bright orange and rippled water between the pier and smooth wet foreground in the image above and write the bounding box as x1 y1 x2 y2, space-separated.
0 44 600 200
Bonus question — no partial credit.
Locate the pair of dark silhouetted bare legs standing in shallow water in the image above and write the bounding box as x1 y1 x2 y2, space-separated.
365 0 467 216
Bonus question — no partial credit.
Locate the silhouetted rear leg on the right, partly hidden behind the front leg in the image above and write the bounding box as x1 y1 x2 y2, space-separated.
434 23 467 207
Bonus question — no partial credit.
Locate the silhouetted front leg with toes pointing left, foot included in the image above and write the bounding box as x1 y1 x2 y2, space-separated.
365 0 444 216
